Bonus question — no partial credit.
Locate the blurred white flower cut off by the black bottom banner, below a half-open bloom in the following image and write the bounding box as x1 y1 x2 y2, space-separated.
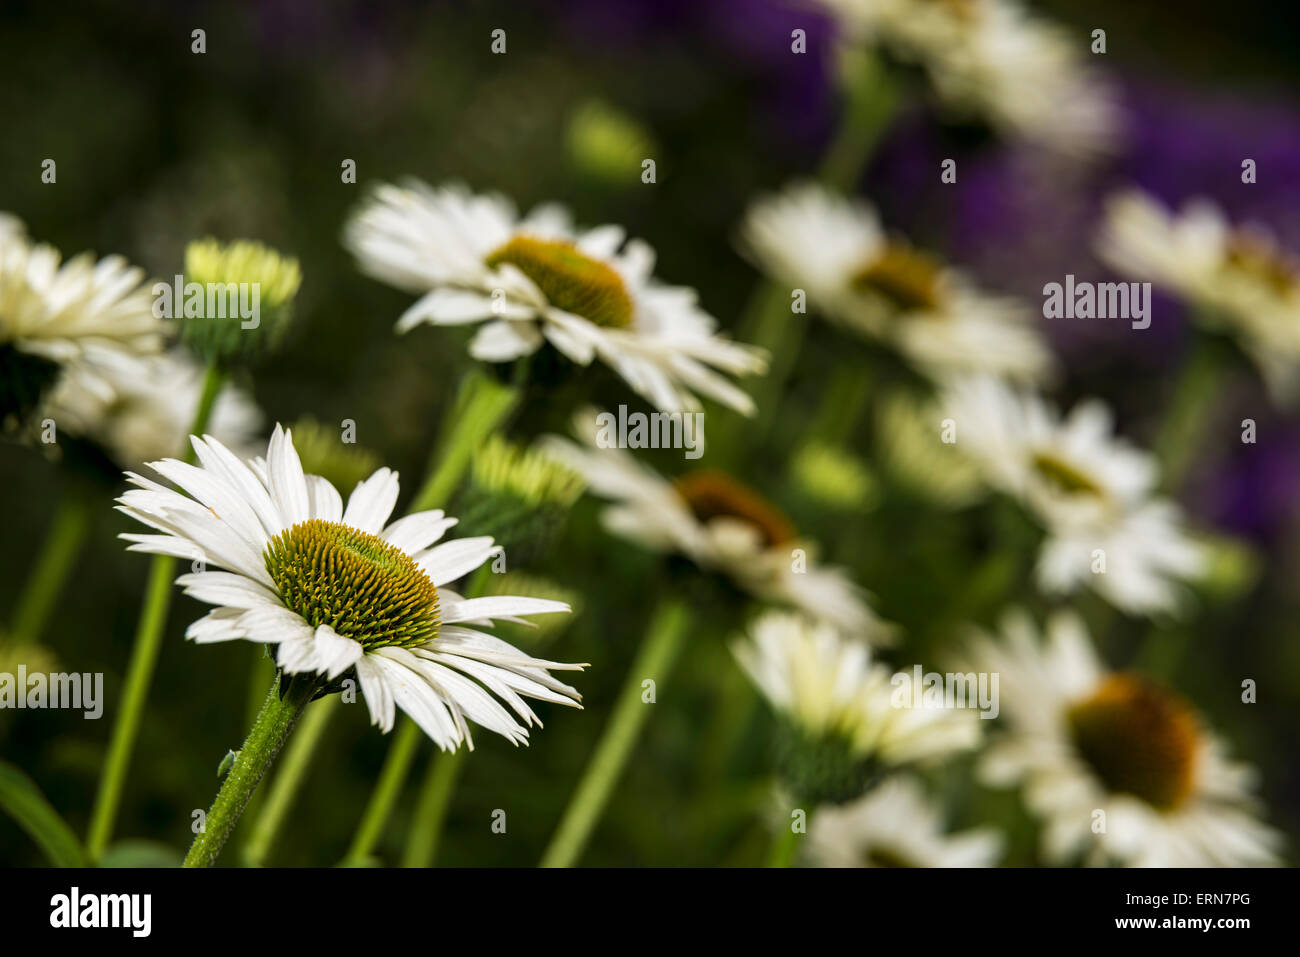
803 774 1004 867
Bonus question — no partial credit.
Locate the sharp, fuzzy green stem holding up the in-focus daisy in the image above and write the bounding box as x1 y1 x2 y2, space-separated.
182 675 319 867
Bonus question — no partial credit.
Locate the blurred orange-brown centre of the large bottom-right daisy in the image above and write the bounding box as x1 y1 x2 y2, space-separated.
1067 674 1200 810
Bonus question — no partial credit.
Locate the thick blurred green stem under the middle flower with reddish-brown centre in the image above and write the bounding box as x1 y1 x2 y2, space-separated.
541 599 689 867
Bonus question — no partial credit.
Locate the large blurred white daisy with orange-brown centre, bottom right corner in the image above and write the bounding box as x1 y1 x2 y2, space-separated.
975 612 1281 867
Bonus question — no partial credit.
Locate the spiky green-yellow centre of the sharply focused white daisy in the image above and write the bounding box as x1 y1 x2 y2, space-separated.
264 519 441 650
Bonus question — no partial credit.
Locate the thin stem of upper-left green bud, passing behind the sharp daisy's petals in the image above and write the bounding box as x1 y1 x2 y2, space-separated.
86 364 225 861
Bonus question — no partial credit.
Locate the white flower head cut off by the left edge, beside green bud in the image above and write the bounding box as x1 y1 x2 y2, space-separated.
0 213 164 415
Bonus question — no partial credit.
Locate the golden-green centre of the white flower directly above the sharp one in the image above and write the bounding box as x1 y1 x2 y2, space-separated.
485 235 633 329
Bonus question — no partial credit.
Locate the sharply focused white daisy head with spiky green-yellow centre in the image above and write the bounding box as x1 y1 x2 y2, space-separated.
118 425 585 750
